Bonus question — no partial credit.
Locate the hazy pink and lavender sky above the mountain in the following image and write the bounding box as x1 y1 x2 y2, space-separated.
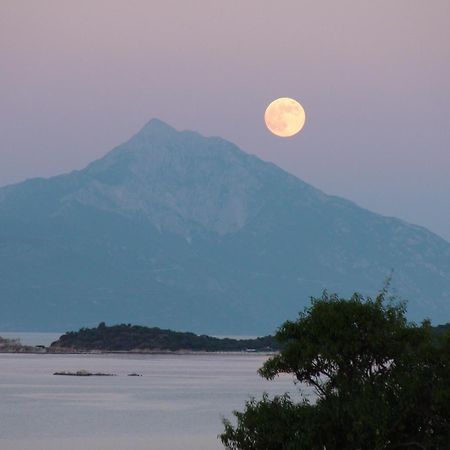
0 0 450 240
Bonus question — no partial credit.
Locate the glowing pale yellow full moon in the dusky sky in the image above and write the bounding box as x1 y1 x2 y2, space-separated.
264 97 306 137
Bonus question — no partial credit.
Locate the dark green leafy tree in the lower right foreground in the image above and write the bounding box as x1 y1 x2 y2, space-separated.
220 291 450 450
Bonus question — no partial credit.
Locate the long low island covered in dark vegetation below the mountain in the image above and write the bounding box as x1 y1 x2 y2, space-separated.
49 322 278 352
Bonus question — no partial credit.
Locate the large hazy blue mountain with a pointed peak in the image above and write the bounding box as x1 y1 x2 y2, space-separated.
0 120 450 334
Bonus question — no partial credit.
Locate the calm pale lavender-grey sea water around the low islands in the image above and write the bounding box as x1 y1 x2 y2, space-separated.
0 332 312 450
